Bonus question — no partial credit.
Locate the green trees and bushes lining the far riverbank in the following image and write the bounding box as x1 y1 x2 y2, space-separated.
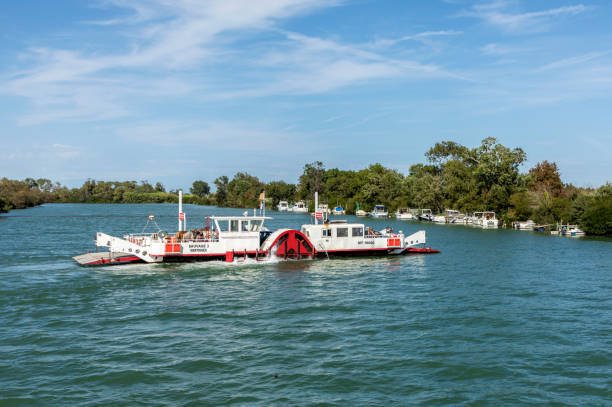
0 137 612 236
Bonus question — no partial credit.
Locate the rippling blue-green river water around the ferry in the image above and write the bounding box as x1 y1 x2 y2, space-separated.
0 204 612 406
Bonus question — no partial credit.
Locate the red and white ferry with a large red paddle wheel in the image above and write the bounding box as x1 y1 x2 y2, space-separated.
74 191 439 266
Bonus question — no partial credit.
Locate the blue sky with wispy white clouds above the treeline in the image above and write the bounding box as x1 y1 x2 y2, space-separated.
0 0 612 189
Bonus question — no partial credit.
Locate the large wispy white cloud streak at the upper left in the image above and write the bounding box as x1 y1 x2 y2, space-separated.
0 0 339 124
